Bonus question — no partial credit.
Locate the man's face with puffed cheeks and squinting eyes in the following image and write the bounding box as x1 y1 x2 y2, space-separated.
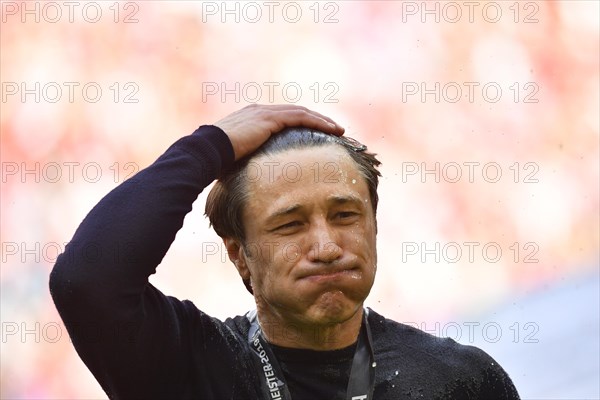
238 145 377 325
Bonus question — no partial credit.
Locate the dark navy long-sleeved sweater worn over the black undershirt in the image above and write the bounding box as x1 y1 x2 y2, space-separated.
50 126 518 400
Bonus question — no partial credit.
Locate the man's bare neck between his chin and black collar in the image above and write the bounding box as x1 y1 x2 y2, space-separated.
257 306 363 350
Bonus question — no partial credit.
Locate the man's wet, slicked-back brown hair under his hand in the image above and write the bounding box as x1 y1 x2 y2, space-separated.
205 127 381 245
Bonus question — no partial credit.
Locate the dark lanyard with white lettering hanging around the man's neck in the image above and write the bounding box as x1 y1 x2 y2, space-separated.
246 308 376 400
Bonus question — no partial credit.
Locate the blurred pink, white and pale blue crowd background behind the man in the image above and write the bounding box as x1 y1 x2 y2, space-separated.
0 1 600 399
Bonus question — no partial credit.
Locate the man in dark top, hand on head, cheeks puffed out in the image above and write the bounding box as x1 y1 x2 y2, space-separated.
50 105 518 400
